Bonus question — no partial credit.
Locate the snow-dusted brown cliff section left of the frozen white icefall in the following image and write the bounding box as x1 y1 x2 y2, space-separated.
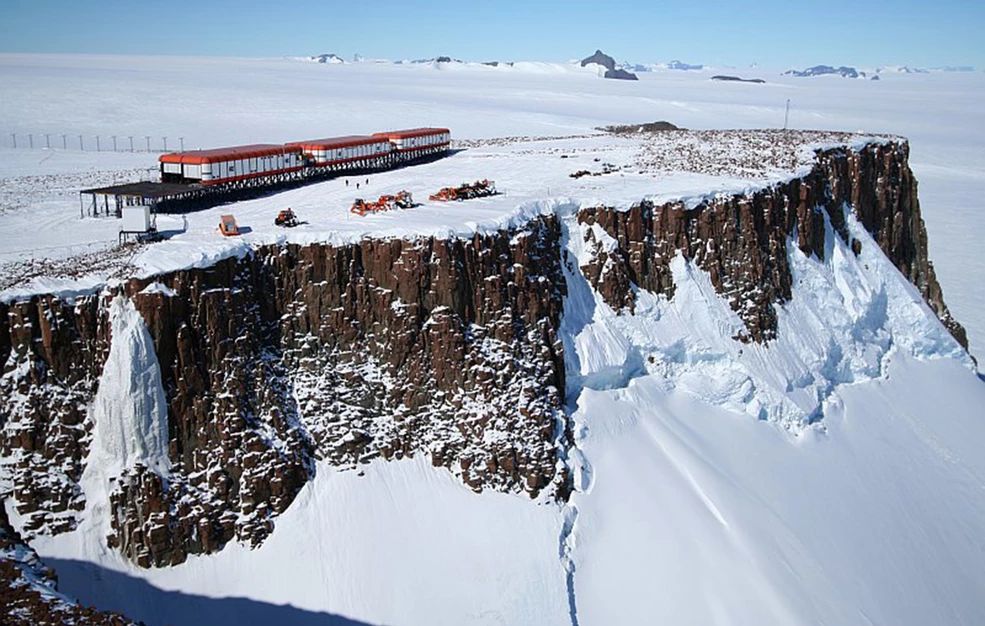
0 296 109 532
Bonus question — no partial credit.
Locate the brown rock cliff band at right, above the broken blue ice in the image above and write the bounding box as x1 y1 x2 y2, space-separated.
578 142 968 348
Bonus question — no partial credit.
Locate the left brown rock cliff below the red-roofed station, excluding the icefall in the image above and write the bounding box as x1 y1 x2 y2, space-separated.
0 217 568 566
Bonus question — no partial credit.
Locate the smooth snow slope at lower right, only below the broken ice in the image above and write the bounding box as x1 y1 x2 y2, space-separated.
574 356 985 625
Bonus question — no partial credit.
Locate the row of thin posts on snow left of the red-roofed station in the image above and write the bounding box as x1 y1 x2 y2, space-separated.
0 132 185 153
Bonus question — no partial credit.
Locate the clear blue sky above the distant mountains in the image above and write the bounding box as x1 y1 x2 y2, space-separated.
0 0 985 68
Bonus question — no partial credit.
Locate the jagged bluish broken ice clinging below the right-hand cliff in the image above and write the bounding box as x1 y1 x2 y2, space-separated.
562 202 974 434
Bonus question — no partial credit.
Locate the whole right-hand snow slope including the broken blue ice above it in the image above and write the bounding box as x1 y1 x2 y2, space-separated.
563 205 985 624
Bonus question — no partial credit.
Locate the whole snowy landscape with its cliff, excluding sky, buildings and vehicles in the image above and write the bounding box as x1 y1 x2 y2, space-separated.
0 55 985 626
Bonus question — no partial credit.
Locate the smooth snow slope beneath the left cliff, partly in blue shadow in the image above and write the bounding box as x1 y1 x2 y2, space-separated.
36 457 570 626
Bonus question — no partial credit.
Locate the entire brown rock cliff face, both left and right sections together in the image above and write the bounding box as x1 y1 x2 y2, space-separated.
0 143 964 567
